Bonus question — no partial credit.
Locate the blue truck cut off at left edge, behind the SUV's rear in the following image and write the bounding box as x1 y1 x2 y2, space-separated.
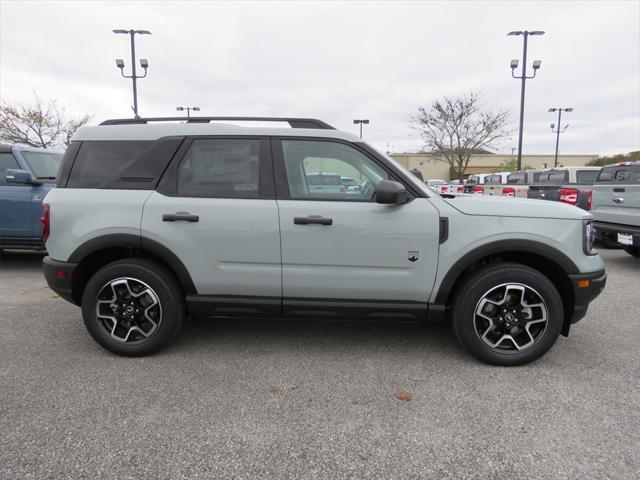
0 144 62 250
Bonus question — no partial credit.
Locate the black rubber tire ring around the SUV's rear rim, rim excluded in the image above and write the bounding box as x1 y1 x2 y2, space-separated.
82 259 185 356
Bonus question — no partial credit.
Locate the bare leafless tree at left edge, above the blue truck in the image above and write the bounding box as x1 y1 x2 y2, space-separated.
0 92 91 148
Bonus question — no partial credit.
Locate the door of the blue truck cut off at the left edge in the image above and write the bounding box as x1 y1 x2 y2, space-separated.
0 152 33 240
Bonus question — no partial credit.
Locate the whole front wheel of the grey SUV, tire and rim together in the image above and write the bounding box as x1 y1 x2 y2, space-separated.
452 263 564 366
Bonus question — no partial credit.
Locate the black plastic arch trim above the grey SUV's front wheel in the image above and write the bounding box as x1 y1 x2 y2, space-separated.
434 240 580 304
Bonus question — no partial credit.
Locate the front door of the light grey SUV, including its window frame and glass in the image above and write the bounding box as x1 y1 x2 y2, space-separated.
274 138 439 316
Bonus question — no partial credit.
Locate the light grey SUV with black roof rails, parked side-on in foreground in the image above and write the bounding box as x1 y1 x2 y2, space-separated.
44 117 606 365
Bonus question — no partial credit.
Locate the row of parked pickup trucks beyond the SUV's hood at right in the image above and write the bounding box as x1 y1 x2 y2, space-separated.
425 161 640 257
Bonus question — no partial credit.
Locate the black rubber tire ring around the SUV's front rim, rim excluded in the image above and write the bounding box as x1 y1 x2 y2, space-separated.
453 264 564 366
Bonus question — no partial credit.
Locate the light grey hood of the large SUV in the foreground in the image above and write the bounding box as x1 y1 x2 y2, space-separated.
443 195 592 220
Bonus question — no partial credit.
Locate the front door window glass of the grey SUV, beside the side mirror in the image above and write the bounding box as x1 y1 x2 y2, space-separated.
282 140 389 201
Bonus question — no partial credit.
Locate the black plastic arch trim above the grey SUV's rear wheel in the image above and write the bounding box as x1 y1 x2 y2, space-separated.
68 233 198 295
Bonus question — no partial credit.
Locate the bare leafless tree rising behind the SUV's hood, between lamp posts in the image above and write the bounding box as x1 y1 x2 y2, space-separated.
412 93 510 180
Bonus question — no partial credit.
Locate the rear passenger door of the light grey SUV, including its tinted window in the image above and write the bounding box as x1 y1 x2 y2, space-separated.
141 137 282 315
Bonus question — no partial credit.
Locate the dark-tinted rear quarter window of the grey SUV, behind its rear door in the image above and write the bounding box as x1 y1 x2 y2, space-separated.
68 141 152 188
